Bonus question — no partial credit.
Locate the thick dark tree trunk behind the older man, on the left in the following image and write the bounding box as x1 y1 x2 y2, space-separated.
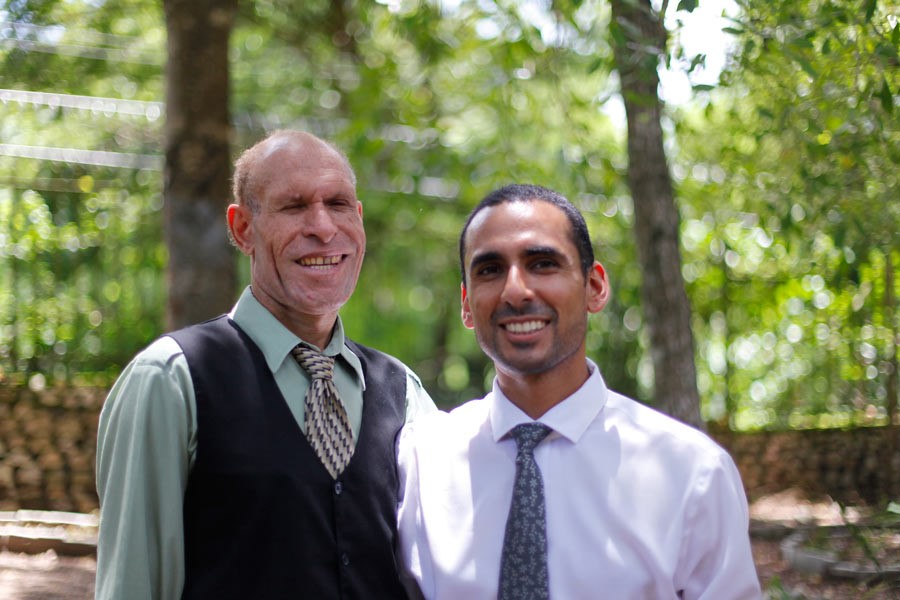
164 0 237 329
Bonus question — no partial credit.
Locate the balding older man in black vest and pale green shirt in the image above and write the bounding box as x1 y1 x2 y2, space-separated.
96 131 434 600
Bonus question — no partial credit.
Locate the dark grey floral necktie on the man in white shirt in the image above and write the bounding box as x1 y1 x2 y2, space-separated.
498 423 551 600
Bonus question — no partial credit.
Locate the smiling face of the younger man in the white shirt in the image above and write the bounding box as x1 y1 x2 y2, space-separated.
462 201 605 376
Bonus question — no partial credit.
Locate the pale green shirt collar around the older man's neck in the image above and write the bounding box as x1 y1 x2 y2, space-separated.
229 286 366 389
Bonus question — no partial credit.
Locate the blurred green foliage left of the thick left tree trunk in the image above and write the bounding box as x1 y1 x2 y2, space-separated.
0 1 165 387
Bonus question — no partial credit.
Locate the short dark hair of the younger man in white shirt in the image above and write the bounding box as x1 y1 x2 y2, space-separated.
459 183 594 285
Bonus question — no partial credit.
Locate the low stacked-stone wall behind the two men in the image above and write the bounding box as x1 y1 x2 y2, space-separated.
0 384 900 513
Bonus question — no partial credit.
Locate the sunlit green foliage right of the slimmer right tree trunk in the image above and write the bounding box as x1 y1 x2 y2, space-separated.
679 2 900 428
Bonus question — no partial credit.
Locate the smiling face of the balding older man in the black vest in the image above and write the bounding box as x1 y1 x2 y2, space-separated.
241 140 366 326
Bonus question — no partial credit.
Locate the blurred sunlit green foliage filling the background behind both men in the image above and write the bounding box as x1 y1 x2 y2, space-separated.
0 0 900 429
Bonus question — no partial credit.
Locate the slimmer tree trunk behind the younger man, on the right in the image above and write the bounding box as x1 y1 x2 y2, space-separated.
611 0 703 428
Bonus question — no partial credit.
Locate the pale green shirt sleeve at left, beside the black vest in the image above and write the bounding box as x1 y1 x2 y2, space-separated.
95 338 196 600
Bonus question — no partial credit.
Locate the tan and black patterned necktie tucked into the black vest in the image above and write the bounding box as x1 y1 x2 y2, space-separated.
291 344 354 479
